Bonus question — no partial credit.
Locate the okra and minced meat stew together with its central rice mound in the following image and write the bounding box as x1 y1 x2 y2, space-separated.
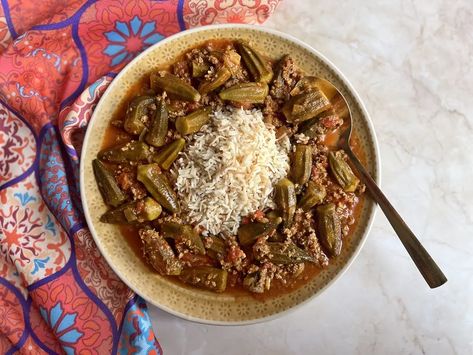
93 40 364 295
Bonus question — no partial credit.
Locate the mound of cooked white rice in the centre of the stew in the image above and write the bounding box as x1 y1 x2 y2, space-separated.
176 108 289 234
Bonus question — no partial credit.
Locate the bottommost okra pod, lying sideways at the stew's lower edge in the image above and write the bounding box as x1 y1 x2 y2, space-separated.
179 266 228 292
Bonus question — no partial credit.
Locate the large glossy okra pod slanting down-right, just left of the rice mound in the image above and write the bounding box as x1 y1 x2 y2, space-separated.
137 164 180 213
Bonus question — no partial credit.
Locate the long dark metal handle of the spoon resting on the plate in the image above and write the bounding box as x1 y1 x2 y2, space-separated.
345 149 447 288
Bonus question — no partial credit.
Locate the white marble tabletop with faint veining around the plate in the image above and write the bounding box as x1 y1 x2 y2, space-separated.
150 0 473 355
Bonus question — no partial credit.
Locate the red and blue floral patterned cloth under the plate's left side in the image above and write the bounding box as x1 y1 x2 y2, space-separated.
0 0 279 354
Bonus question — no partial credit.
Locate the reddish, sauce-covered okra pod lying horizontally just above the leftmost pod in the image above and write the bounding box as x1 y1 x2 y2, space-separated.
98 141 151 163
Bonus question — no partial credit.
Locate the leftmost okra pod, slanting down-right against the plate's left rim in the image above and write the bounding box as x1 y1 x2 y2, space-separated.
92 159 126 207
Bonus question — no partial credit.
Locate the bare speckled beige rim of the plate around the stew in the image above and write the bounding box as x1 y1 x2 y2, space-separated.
80 25 379 325
